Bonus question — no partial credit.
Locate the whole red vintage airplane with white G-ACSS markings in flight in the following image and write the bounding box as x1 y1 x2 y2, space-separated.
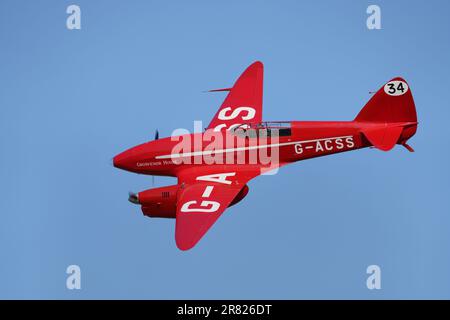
113 62 417 250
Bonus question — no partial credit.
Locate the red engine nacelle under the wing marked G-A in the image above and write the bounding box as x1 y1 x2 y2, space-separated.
132 185 248 218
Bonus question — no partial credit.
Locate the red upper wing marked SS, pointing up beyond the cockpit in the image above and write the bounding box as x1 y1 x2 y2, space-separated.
207 61 264 131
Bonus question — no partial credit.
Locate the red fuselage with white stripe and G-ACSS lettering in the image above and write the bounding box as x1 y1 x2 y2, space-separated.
114 121 417 176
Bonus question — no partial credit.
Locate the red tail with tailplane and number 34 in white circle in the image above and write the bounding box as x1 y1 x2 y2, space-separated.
354 78 417 151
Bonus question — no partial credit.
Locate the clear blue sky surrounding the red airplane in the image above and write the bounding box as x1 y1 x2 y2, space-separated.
0 0 450 299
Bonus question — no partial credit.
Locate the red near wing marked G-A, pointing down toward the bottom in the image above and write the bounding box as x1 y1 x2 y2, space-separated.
175 166 259 250
